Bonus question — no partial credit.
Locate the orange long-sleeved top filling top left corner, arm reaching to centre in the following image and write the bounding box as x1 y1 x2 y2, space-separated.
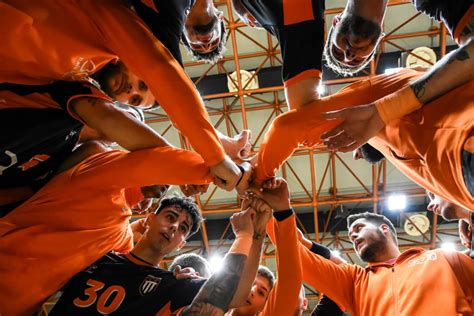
0 0 225 165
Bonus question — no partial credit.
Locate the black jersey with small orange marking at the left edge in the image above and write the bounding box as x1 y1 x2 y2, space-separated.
0 108 83 188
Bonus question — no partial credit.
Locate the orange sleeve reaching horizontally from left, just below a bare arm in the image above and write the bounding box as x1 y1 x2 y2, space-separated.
71 147 212 188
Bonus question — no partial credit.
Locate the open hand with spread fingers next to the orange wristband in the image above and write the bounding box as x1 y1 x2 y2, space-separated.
321 103 385 152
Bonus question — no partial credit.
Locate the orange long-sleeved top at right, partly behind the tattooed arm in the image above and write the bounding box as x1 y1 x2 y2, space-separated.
255 70 474 210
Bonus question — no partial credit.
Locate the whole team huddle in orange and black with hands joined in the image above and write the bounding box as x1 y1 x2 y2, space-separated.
0 0 474 316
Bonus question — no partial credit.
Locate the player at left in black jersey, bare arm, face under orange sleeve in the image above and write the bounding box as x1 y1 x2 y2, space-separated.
0 62 169 213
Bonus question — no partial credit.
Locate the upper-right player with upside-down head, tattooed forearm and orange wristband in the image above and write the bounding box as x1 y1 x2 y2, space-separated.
321 0 474 156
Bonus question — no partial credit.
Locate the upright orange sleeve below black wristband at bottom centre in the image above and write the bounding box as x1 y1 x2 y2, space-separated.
262 214 303 316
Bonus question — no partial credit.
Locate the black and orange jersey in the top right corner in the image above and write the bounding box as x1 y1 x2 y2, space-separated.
412 0 474 42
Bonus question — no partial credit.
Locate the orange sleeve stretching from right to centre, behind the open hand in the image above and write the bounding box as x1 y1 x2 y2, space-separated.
254 70 422 184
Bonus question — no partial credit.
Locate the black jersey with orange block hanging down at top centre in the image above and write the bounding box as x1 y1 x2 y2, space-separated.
241 0 325 85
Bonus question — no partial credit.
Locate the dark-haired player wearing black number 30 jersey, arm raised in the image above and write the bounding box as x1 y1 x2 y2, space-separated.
51 197 271 315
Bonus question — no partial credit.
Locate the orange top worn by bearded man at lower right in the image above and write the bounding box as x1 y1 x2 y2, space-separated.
300 246 474 316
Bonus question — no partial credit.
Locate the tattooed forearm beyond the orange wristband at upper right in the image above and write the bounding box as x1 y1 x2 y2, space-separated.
410 37 474 104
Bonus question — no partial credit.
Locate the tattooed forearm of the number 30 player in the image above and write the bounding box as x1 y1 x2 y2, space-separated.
182 254 247 316
